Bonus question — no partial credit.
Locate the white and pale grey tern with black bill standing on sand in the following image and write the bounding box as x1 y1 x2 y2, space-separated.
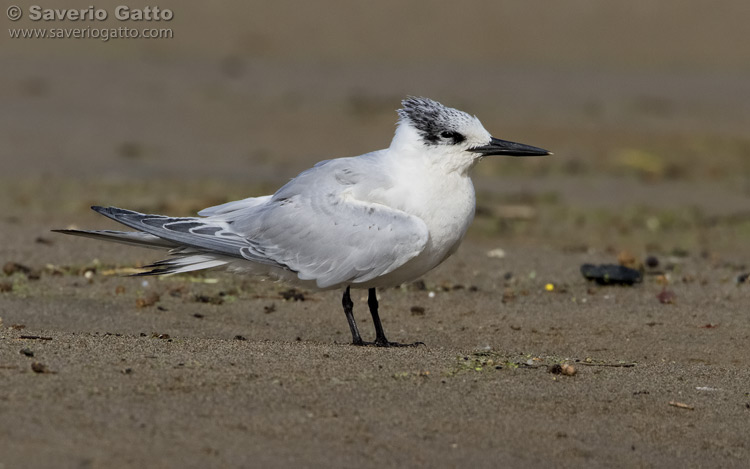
55 97 550 347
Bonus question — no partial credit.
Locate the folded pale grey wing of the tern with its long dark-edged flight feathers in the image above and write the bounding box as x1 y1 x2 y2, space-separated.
76 152 429 288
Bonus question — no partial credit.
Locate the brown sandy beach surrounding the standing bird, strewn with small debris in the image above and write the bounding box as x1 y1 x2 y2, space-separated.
0 2 750 468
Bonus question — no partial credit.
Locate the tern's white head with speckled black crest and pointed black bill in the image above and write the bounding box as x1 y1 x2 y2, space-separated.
391 97 551 170
